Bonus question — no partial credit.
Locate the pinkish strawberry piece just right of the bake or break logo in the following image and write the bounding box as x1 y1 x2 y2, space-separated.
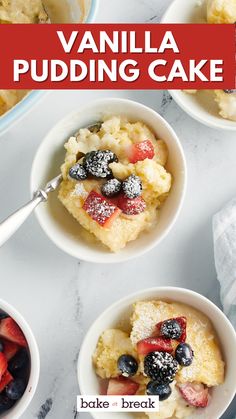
178 383 209 407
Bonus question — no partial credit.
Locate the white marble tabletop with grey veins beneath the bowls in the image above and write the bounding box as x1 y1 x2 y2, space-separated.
0 0 236 419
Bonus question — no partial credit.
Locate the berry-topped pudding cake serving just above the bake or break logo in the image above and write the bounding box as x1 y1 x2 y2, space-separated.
92 301 225 419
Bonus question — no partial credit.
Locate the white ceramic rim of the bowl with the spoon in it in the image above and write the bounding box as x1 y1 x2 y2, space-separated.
30 98 187 264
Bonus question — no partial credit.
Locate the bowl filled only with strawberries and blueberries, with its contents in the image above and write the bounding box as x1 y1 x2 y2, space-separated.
0 300 40 419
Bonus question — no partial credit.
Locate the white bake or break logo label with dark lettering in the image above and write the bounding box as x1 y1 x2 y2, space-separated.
77 396 159 413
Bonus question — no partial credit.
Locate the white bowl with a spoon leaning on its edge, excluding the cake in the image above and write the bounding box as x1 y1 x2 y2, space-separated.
31 99 186 263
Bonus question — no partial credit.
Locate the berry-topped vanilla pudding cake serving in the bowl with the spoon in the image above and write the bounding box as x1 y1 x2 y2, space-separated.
58 116 172 252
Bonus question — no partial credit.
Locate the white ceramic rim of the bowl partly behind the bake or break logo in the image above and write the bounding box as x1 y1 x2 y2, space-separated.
77 286 236 419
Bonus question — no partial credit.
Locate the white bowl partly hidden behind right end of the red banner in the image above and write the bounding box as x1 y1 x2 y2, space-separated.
161 0 236 131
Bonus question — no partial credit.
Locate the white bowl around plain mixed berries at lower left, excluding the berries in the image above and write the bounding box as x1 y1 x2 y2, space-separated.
0 299 40 419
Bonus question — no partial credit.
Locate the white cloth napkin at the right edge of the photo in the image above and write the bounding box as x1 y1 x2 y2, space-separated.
213 198 236 328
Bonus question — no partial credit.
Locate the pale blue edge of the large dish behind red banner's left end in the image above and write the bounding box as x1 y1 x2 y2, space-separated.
0 0 99 135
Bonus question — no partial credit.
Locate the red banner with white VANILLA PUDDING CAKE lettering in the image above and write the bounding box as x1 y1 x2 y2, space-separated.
0 24 236 89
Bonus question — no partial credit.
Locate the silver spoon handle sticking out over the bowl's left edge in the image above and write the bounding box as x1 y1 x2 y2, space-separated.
0 191 46 247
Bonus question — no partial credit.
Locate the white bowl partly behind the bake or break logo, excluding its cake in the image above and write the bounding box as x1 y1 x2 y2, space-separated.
77 287 236 419
